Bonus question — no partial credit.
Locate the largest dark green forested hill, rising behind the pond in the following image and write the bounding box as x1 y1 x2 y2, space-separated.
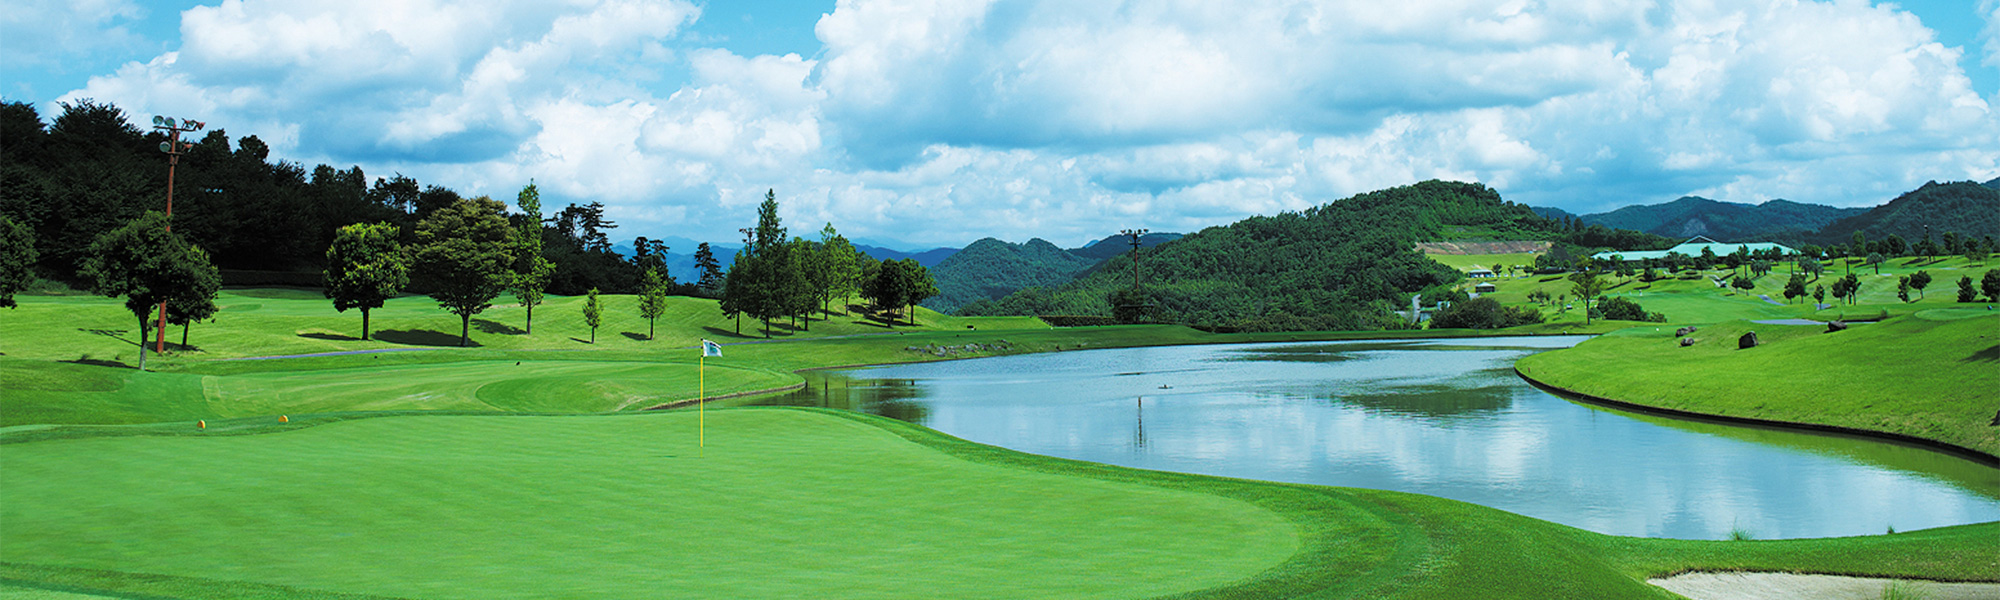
960 180 1568 330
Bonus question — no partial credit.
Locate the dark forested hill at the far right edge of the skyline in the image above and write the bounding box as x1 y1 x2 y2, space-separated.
1812 182 2000 244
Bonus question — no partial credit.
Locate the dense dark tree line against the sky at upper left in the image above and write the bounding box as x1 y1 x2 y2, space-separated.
0 100 720 298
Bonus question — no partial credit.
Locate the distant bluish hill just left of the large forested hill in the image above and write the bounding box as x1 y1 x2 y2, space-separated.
924 238 1096 314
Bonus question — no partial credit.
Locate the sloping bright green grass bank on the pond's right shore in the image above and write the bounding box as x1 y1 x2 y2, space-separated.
1514 308 2000 454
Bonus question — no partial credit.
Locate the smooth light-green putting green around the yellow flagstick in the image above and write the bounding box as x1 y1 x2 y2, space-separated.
0 410 1300 598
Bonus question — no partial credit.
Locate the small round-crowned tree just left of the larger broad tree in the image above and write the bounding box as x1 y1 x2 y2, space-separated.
320 222 410 340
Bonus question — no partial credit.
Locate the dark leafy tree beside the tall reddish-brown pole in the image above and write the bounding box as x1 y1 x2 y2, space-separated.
82 210 218 370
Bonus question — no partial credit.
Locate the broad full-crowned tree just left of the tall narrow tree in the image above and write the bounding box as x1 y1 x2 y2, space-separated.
414 196 520 346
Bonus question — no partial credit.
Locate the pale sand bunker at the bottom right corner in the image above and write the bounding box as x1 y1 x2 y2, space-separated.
1648 572 2000 600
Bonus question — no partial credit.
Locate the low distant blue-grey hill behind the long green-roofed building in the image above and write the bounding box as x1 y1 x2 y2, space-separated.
1582 196 1868 242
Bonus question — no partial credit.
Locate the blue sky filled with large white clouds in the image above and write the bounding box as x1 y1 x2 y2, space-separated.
0 0 2000 252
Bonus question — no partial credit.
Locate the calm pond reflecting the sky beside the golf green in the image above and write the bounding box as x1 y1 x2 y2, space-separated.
770 336 2000 540
